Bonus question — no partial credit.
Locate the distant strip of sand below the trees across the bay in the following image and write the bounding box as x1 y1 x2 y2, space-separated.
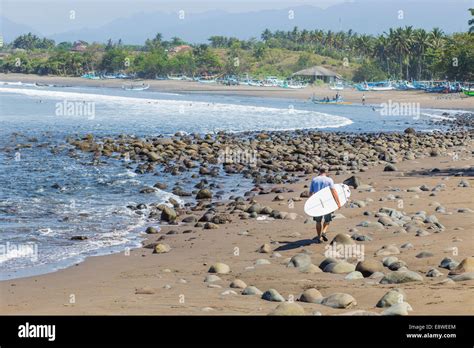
0 73 474 111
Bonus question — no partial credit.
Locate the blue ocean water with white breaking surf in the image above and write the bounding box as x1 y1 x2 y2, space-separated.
0 84 466 279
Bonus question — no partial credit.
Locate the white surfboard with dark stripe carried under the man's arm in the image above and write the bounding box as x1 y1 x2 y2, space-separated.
304 184 351 216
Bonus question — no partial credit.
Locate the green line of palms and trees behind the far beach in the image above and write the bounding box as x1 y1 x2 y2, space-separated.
0 9 474 81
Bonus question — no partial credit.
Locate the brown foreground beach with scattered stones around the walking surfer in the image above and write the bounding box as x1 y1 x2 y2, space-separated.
0 124 474 315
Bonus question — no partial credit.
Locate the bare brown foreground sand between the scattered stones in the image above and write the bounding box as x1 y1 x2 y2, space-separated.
0 128 474 315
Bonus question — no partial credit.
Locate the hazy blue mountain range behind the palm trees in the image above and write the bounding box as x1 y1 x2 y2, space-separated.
1 0 471 44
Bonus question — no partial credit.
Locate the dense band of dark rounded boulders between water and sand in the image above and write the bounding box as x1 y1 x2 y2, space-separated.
68 123 472 229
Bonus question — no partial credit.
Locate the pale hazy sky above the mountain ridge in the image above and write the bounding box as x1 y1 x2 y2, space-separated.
0 0 348 35
